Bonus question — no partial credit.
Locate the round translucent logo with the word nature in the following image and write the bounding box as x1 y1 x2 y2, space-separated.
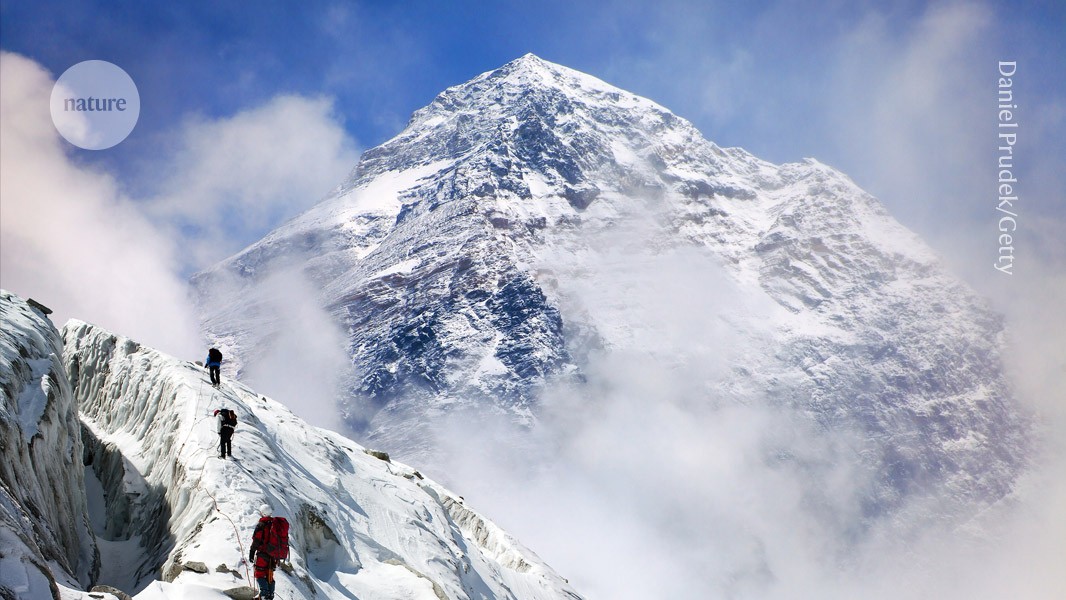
51 61 141 150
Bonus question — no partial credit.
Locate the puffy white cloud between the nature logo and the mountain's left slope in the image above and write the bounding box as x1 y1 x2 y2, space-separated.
148 96 358 267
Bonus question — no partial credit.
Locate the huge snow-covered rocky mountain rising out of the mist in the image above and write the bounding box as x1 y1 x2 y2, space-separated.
194 54 1027 514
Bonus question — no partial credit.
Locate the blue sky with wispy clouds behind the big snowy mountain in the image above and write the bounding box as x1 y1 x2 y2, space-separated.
0 0 1066 349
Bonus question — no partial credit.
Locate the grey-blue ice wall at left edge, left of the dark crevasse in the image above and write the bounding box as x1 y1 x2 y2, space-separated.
0 291 98 598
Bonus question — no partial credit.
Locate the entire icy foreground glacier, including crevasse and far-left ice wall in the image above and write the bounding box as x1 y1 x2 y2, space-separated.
0 292 580 600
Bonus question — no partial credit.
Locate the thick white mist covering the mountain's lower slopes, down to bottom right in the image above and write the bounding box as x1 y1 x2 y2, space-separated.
428 208 1066 600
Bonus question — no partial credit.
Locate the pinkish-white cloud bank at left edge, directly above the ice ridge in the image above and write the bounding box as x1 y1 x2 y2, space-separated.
0 52 199 357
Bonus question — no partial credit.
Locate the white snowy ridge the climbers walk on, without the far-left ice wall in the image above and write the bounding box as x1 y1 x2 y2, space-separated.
63 321 580 600
